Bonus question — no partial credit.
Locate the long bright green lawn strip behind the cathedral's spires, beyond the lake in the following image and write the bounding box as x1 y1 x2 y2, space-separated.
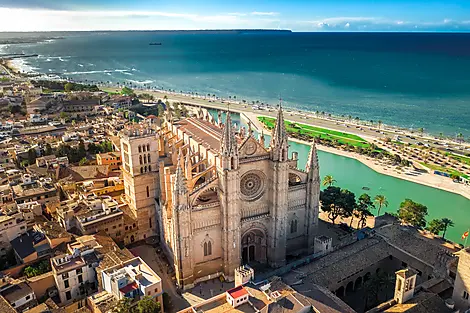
258 116 370 148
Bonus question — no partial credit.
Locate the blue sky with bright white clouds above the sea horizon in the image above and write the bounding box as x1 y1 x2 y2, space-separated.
0 0 470 31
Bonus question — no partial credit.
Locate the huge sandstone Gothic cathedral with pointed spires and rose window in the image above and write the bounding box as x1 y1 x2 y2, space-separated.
119 108 320 289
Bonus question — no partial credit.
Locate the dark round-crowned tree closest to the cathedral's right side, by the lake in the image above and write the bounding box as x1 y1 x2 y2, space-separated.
320 186 356 224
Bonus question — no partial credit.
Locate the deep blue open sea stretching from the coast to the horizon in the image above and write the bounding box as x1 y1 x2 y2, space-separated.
0 31 470 138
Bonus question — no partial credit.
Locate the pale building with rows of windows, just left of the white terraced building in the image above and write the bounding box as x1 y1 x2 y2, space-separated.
51 249 98 304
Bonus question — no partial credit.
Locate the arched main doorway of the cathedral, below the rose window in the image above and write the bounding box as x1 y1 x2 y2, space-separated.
242 229 267 264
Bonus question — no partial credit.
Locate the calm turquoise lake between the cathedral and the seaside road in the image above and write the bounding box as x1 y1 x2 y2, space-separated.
290 142 470 244
